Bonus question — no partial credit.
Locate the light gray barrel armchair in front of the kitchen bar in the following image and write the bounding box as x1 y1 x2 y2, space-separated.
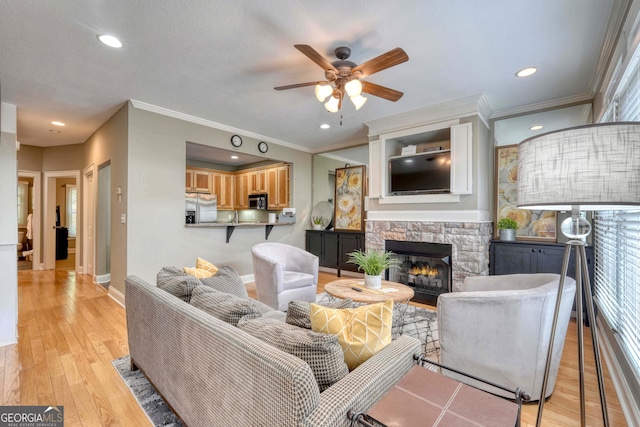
251 243 318 311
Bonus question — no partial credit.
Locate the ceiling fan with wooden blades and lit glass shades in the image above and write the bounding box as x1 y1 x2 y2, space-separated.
274 44 409 113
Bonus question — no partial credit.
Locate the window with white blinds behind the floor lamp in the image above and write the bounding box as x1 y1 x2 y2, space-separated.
594 41 640 377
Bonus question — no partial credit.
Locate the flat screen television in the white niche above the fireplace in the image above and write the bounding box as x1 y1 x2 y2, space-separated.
389 150 451 195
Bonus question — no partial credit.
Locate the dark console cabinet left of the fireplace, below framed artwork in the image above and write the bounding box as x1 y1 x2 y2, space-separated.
306 230 365 277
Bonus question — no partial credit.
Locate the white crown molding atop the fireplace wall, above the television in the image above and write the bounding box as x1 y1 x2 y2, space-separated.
365 94 491 137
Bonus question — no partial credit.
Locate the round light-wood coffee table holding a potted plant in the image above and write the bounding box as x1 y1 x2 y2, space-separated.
324 279 414 337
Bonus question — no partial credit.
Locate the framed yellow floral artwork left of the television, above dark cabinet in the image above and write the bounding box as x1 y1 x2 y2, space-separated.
333 166 366 231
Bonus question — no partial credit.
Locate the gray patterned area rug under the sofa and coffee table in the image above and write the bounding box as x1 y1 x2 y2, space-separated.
112 293 440 427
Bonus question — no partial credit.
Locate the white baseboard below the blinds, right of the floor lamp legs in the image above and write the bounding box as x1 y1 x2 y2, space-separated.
596 316 640 426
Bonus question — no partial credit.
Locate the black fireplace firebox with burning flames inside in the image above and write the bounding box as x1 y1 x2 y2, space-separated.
385 240 452 305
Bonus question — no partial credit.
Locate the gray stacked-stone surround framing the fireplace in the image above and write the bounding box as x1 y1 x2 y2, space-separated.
365 219 492 294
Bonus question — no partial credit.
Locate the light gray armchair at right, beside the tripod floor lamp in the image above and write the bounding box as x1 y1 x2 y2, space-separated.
438 274 576 400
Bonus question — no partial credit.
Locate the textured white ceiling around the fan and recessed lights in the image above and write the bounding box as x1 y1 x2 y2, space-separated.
0 0 614 150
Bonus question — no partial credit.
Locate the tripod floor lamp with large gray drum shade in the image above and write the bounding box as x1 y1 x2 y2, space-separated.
518 122 640 426
